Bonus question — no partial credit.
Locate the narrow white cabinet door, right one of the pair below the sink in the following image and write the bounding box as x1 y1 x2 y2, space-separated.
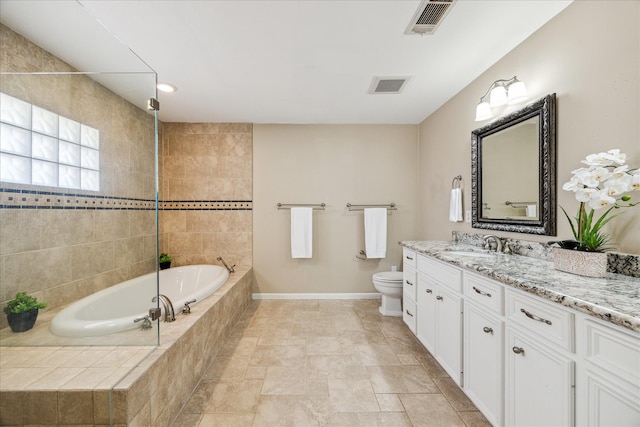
435 288 462 386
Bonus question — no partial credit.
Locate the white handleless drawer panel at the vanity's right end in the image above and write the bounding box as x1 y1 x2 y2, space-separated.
584 319 640 384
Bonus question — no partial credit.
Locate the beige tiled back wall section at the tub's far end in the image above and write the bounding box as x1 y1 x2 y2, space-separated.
160 123 253 266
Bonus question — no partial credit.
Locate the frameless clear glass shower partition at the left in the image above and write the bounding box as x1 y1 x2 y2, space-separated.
0 0 160 425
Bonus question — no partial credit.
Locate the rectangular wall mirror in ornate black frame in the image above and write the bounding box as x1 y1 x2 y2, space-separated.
471 94 556 235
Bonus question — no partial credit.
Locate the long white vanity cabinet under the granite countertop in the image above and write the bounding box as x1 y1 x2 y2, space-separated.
404 248 640 427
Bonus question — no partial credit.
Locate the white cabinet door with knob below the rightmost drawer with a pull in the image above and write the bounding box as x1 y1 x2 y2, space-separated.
505 328 574 427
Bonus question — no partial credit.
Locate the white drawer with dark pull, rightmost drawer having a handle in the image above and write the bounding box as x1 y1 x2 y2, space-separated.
506 289 575 352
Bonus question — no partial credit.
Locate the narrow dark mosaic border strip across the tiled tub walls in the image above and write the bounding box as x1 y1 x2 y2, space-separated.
0 188 253 210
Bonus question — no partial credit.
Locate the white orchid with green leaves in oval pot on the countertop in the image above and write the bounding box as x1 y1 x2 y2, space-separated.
549 149 640 277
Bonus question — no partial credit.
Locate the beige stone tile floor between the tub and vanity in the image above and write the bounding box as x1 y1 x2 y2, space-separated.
173 300 490 427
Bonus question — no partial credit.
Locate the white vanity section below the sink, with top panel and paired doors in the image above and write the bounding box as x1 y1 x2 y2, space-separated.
416 255 462 386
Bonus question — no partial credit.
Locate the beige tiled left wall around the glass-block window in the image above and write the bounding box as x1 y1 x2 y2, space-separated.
0 25 156 328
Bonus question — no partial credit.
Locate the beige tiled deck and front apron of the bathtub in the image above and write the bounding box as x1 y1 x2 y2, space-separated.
0 267 252 426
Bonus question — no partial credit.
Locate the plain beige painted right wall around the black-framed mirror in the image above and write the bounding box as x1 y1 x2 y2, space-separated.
419 1 640 254
